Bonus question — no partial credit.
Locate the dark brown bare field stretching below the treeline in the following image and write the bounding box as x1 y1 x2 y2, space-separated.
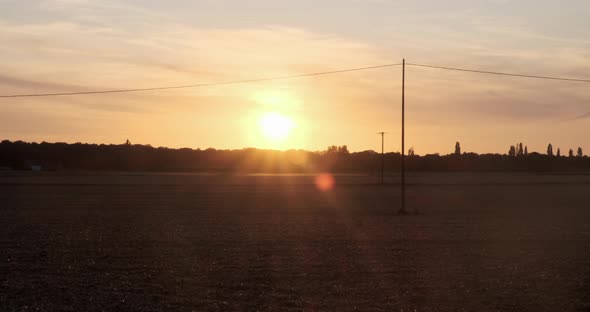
0 173 590 311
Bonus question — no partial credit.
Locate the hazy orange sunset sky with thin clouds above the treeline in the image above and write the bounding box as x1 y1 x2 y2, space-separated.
0 0 590 154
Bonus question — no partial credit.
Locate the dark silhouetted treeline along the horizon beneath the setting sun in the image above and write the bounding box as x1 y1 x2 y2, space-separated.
0 140 590 174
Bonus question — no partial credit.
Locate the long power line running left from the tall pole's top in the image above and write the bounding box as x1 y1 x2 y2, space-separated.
0 63 401 98
